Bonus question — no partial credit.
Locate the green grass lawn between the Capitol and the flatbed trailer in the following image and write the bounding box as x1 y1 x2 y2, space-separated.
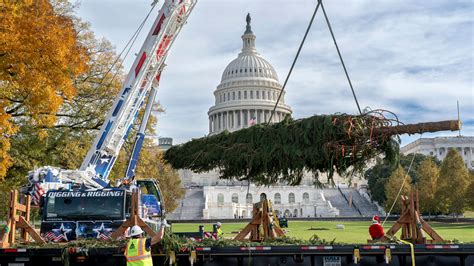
173 220 474 243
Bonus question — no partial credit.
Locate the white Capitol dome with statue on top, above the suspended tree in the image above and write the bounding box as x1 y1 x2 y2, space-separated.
208 15 292 134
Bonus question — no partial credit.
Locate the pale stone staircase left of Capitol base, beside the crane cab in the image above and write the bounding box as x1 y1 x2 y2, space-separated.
166 188 204 220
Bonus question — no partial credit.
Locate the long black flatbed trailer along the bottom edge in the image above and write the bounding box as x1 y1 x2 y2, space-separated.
0 244 474 266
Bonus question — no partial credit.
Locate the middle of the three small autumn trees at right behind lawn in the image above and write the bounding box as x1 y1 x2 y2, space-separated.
416 158 439 219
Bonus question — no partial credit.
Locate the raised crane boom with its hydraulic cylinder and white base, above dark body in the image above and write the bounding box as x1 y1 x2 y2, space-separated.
28 0 196 203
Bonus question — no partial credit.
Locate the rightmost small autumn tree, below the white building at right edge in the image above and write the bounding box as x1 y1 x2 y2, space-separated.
436 149 470 218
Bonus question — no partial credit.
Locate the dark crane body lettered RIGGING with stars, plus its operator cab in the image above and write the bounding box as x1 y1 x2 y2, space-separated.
40 179 164 242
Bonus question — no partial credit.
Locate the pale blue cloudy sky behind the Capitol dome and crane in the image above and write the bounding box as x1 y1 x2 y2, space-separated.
77 0 474 145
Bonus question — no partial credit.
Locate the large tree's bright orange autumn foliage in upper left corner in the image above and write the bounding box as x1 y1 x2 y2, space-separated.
0 0 88 178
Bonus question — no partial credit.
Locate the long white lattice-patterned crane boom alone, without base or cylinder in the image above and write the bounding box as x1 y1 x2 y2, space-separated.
80 0 196 186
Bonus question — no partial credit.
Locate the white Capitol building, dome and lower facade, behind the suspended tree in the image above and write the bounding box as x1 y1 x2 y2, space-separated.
170 15 377 219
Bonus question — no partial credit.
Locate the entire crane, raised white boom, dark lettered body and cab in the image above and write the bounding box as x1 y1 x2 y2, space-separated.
19 0 197 242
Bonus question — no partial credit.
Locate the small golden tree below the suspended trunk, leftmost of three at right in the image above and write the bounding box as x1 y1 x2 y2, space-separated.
384 166 412 213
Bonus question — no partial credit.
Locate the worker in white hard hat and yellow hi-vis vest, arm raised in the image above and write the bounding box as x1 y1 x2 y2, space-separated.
125 221 168 266
